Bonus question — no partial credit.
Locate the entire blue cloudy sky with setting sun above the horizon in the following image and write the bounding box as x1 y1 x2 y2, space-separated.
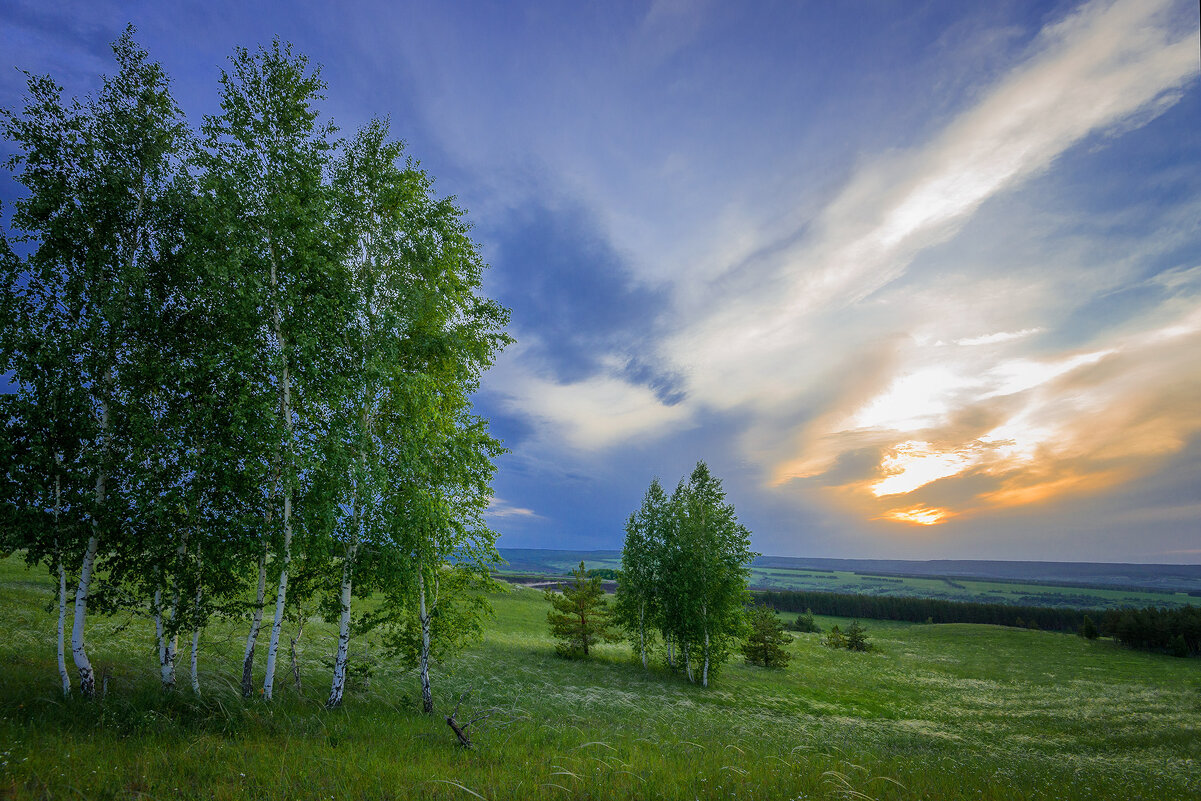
0 0 1201 563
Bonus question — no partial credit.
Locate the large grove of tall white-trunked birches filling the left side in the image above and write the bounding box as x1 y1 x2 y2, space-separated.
0 29 510 711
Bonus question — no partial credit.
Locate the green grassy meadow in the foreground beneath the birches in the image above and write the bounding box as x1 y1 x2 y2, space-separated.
0 558 1201 801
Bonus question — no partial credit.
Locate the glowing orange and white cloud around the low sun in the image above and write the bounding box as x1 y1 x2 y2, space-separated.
797 297 1201 525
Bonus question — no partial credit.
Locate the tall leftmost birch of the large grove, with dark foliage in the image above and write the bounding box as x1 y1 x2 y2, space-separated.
4 28 186 697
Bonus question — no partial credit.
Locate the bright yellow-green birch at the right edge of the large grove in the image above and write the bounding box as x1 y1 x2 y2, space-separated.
375 153 512 713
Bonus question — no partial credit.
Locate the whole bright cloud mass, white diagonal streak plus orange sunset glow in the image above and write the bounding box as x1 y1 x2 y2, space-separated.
510 0 1201 533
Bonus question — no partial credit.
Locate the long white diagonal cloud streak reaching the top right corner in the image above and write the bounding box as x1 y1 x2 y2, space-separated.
669 0 1199 407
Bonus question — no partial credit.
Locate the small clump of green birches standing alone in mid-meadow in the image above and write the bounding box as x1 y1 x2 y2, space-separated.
614 462 758 687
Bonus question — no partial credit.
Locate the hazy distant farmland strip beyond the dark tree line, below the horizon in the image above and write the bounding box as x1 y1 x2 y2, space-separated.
504 549 1201 609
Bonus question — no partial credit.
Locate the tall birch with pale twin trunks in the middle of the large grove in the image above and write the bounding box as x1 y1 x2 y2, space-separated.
203 40 346 698
